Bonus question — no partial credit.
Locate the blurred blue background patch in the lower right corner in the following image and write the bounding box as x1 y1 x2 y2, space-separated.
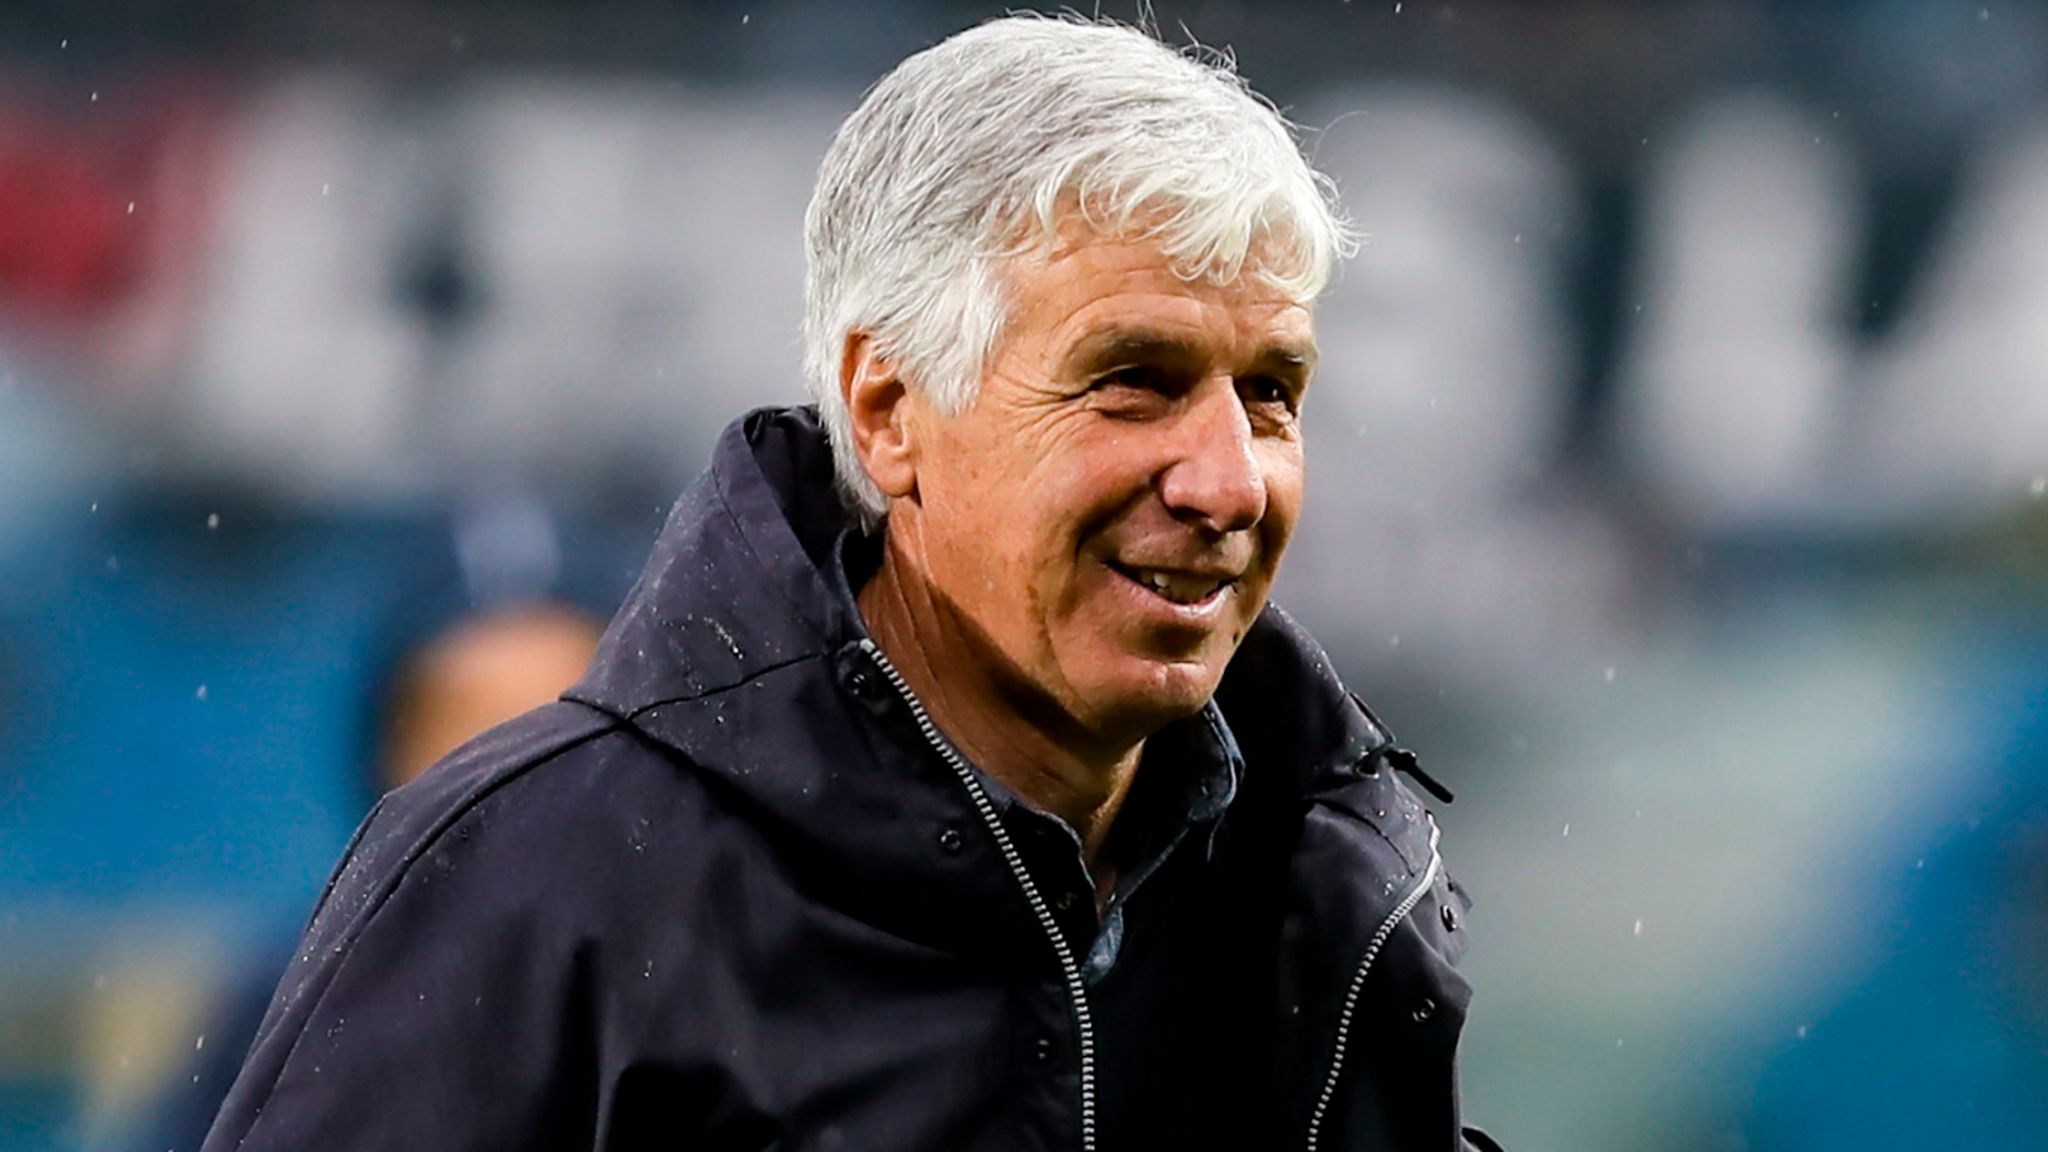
1747 639 2048 1152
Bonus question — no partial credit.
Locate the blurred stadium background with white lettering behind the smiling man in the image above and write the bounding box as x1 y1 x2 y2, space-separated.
0 0 2048 1152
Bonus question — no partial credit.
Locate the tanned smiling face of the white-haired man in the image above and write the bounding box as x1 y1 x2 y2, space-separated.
893 230 1315 736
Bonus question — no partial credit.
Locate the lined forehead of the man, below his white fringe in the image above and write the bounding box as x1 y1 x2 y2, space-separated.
1006 225 1315 359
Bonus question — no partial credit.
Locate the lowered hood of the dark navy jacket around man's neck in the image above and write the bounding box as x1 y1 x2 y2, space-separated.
567 406 1386 942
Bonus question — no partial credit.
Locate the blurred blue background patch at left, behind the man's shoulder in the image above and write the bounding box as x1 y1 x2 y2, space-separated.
0 498 409 920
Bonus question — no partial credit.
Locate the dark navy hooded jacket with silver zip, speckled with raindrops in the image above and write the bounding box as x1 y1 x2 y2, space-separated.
207 408 1491 1152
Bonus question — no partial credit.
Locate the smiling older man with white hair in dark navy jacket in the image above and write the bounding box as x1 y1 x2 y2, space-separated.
207 16 1485 1152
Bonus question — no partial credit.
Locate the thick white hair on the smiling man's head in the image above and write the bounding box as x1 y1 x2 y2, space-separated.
803 14 1356 525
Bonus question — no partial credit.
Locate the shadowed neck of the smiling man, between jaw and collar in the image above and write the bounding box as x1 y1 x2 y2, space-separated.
858 520 1145 867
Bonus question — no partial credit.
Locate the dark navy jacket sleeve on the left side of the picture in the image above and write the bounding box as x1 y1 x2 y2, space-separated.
205 705 596 1152
